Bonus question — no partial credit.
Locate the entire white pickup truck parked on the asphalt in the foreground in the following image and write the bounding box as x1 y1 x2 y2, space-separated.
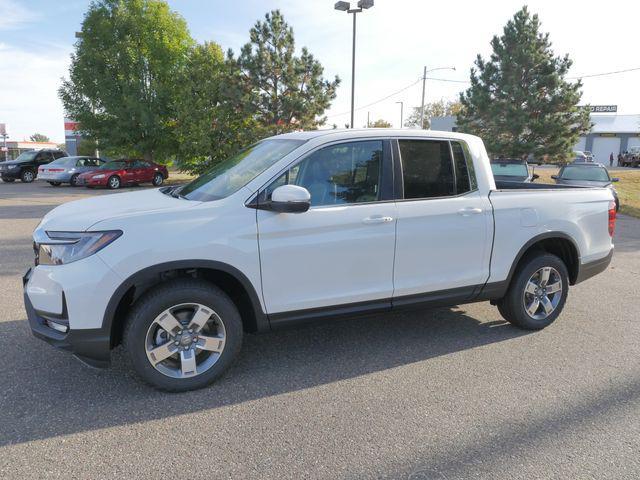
24 129 615 391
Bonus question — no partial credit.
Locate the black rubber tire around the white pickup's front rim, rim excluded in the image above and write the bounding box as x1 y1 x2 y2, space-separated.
123 279 243 392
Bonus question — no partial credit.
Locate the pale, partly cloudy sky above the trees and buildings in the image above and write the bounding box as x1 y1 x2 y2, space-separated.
0 0 640 142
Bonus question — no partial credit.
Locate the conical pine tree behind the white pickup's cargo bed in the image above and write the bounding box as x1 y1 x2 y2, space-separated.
457 6 591 159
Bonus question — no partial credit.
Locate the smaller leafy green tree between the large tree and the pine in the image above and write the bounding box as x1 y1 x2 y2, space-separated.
175 42 257 173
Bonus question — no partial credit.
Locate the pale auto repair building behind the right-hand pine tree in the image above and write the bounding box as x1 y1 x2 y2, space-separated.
431 112 640 165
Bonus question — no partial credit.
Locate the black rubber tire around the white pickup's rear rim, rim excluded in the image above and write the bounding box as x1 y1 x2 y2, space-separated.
501 253 569 330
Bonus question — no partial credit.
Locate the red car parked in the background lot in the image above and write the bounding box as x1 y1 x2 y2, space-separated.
77 160 169 190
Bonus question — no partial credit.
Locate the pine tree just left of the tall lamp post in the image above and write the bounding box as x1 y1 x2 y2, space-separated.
230 10 340 134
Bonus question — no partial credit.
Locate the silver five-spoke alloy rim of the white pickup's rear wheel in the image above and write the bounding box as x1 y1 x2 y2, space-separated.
523 267 562 320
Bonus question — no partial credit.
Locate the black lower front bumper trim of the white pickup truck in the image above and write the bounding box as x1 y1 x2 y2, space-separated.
22 269 111 368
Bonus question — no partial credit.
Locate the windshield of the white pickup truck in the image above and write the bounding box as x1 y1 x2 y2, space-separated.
180 139 305 202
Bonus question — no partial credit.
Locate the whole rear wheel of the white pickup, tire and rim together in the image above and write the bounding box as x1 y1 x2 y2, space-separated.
498 252 569 330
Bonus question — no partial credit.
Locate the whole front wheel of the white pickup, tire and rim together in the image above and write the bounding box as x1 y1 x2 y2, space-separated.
123 278 243 392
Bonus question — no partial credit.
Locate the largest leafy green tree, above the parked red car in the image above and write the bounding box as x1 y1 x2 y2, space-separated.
59 0 193 160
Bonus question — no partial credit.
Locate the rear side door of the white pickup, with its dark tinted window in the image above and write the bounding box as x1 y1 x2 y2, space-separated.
394 139 492 304
